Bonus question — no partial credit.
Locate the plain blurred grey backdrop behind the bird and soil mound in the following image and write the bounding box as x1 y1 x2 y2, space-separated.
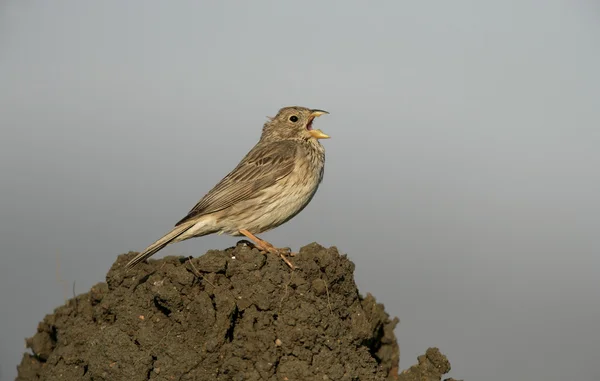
0 0 600 381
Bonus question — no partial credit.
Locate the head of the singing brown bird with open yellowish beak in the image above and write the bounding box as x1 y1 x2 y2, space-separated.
261 106 329 140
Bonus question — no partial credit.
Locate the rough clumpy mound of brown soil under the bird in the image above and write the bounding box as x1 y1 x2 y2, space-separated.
17 244 460 381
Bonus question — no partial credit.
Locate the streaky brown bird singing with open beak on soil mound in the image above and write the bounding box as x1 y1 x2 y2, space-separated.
125 106 329 269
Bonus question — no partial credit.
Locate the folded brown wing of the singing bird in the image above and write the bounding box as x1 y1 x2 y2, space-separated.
175 141 298 226
